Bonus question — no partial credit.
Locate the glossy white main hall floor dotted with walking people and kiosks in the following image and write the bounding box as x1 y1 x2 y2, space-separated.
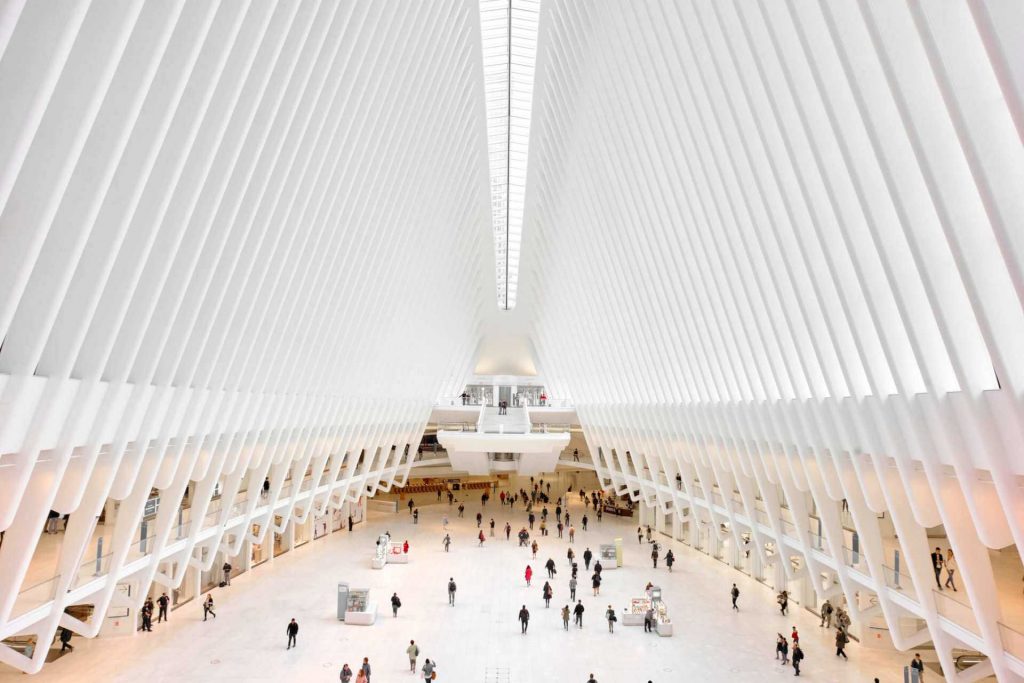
0 493 909 683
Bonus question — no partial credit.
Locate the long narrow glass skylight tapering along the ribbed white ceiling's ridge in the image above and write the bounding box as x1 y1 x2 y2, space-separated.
480 0 541 310
